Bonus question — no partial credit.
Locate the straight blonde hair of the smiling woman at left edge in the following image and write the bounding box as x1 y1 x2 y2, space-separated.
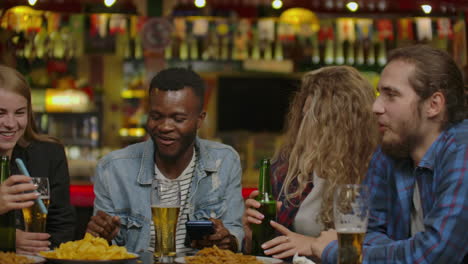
0 64 59 147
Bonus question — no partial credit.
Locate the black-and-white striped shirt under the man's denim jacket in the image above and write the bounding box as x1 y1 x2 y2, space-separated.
148 150 197 254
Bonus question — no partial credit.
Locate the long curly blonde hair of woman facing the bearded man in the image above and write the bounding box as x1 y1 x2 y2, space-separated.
273 66 379 227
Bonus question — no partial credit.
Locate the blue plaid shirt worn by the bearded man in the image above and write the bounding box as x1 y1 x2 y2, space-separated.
322 119 468 263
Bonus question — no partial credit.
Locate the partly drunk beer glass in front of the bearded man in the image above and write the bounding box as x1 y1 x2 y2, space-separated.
333 184 369 264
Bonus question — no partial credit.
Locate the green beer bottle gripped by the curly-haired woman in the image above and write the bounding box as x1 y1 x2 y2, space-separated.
252 159 276 256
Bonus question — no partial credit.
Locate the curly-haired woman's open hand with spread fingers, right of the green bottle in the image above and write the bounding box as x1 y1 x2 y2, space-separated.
262 221 315 259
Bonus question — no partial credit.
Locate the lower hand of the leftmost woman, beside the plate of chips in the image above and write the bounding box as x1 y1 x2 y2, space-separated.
16 229 50 255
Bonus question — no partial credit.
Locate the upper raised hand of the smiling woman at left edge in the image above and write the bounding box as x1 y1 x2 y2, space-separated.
0 175 39 214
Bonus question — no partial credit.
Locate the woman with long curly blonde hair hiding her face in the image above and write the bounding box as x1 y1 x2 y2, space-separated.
244 66 378 258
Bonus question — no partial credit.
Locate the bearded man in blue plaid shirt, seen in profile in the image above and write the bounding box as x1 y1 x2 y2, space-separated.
313 45 468 263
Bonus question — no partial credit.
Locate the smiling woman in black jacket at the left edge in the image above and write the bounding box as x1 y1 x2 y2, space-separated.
0 65 75 254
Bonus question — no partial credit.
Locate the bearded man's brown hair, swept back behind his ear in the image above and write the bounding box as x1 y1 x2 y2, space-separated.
388 45 467 128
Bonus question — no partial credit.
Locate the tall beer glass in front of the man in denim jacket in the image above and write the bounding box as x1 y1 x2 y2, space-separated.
151 179 181 263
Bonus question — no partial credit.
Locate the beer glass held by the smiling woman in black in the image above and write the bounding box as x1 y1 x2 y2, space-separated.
23 177 50 233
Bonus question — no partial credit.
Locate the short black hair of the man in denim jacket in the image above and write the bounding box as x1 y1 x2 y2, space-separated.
149 68 205 108
